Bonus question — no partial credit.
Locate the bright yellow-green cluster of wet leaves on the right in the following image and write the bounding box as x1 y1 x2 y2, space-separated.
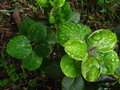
57 22 119 82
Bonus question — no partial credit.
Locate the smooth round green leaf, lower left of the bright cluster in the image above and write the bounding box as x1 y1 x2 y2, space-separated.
60 55 81 77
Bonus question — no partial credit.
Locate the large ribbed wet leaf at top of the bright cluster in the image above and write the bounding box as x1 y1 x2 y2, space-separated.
57 22 91 45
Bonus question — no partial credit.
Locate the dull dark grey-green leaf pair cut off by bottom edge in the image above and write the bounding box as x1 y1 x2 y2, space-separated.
62 77 84 90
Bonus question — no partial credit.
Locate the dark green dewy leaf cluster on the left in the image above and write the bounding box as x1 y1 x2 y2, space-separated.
6 17 51 71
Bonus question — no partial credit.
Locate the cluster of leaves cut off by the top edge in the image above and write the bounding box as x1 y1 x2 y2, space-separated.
36 0 80 24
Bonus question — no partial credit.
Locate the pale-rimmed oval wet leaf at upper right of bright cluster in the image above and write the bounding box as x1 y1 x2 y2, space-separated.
88 29 117 52
